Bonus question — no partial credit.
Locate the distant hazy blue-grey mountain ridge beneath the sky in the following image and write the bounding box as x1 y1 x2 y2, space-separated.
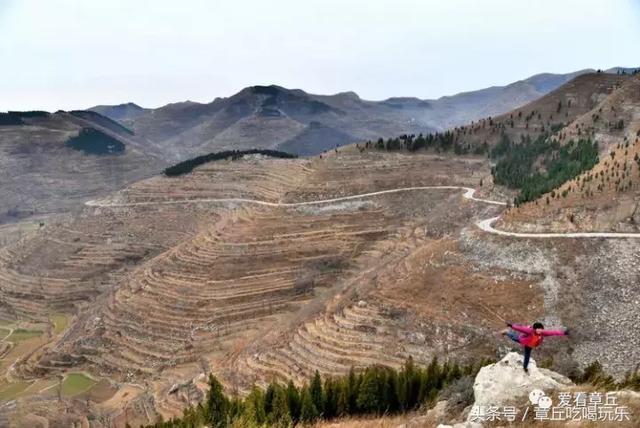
89 69 617 160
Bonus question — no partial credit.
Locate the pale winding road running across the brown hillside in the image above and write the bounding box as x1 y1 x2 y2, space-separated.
85 186 640 239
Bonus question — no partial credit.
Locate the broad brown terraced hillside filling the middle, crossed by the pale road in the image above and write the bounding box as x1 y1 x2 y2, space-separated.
0 142 640 426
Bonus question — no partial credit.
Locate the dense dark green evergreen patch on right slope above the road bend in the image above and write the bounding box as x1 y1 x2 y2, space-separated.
491 133 598 205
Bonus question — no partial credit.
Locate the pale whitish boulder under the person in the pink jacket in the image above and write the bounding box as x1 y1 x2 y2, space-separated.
473 352 571 406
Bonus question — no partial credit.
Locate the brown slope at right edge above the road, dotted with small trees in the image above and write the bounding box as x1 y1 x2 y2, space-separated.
505 76 640 231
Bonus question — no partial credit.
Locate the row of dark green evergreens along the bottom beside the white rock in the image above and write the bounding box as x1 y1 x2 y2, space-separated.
147 358 490 428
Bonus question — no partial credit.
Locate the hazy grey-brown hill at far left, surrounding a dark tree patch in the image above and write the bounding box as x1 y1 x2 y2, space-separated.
0 112 163 222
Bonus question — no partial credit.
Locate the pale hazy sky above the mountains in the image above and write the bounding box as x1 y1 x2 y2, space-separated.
0 0 640 111
